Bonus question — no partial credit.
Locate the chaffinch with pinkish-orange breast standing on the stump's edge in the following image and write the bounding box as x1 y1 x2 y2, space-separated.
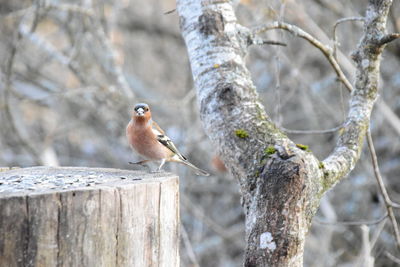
126 103 210 176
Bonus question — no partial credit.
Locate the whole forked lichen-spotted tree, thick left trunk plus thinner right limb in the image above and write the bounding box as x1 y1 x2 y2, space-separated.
177 0 391 266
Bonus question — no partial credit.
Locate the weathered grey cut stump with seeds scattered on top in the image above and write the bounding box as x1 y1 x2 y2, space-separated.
0 167 179 267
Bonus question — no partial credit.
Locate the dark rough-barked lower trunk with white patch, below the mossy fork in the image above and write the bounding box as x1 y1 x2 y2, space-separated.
241 153 323 266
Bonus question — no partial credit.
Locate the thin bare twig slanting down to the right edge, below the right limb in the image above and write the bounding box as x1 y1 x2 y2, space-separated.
367 130 400 250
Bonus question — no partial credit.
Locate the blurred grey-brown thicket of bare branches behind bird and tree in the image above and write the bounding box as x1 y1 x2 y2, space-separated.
0 0 400 267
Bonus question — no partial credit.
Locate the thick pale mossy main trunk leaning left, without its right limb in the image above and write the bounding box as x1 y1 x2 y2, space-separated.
178 1 323 266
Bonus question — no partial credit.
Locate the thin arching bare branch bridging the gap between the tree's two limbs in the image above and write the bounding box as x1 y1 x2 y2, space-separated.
252 21 353 91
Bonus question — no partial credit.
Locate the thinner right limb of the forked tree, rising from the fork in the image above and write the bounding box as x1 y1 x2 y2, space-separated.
324 0 391 188
